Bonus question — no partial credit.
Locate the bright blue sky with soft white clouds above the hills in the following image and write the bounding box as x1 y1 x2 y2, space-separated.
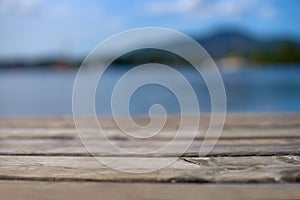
0 0 300 58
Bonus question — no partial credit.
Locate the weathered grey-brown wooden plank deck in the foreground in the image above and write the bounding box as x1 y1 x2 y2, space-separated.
0 114 300 200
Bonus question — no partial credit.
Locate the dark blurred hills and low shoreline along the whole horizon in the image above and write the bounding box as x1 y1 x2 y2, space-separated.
0 29 300 68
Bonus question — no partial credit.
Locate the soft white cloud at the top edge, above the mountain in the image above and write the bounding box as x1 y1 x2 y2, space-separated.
143 0 276 19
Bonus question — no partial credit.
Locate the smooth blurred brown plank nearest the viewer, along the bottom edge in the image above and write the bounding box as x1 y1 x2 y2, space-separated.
0 181 300 200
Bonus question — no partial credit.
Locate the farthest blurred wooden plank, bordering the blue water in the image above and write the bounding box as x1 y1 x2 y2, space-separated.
0 113 300 128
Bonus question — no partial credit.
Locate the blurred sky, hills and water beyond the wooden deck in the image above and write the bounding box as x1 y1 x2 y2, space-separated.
0 0 300 117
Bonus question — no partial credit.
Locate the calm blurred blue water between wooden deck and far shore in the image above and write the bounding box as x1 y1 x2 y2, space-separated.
0 66 300 116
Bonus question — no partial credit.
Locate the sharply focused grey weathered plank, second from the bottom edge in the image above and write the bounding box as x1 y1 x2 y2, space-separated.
0 156 300 183
